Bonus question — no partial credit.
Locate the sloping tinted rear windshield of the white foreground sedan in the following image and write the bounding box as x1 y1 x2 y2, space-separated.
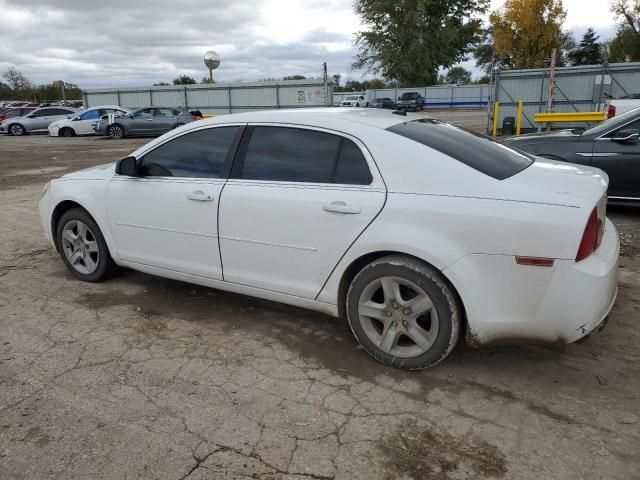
387 118 533 180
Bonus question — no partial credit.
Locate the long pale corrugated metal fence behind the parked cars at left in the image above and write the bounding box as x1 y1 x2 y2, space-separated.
83 80 333 114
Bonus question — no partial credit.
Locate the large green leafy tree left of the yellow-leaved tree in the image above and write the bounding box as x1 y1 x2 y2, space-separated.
353 0 489 85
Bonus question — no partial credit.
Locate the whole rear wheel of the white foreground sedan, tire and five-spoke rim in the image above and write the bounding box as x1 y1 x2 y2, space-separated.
346 255 462 370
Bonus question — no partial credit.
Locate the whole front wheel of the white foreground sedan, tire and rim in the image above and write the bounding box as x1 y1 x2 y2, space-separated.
56 208 115 282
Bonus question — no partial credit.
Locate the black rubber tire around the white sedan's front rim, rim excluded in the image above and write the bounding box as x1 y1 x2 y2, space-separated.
56 208 116 282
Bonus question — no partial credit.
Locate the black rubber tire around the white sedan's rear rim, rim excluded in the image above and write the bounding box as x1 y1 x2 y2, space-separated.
345 255 463 370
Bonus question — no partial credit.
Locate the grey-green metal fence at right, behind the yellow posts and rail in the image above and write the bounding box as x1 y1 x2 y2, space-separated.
487 63 640 131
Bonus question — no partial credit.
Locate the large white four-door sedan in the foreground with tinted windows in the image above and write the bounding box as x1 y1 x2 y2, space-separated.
40 109 619 369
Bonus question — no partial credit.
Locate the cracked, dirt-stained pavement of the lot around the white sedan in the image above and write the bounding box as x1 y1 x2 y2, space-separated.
0 124 640 480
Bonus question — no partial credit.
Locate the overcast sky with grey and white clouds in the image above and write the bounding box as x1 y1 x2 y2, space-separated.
0 0 614 88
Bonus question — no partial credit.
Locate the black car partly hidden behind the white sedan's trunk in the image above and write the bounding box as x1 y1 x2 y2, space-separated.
505 108 640 203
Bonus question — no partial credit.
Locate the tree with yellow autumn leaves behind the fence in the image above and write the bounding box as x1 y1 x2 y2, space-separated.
489 0 567 68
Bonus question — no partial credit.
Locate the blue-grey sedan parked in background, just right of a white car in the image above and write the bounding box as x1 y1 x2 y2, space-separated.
94 107 196 139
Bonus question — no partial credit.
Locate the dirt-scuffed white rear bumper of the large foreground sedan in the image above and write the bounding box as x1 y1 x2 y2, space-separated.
444 219 620 344
